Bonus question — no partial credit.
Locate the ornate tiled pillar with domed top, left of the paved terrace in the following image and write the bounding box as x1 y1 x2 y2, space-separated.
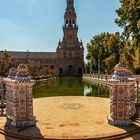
5 64 35 127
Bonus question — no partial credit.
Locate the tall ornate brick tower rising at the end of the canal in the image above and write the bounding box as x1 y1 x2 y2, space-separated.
56 0 84 76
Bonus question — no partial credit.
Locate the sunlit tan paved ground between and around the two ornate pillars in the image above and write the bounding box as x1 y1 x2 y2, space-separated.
0 97 140 140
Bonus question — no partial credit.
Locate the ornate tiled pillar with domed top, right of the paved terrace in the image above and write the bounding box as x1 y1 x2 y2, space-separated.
108 64 136 125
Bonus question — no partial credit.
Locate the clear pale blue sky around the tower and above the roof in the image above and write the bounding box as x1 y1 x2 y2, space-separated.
0 0 120 57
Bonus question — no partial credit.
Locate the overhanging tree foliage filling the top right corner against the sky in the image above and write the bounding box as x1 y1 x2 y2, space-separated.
115 0 140 65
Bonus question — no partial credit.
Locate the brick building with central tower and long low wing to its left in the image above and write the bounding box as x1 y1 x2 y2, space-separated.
0 0 84 76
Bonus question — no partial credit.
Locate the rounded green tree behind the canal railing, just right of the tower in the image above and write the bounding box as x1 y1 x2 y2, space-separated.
87 33 122 73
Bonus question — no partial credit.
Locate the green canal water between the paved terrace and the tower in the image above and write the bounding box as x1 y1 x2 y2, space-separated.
33 77 109 98
